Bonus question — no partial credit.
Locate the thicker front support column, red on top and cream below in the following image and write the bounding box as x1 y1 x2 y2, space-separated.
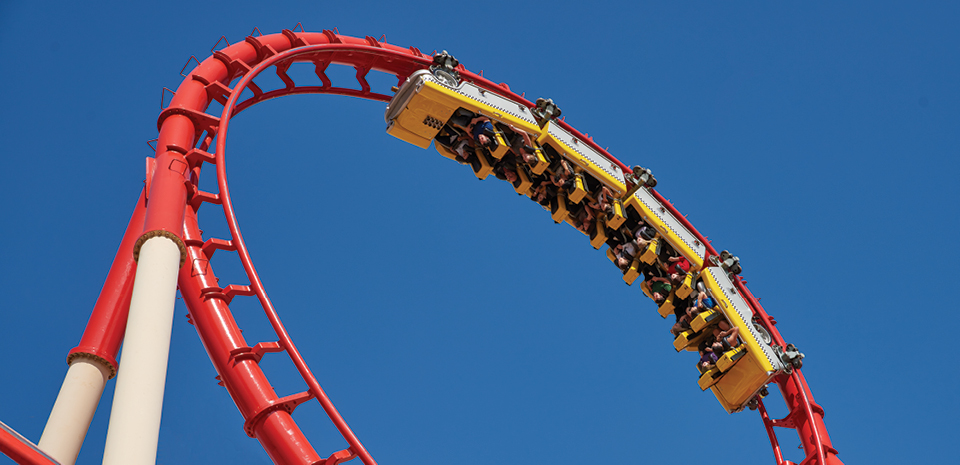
103 125 195 465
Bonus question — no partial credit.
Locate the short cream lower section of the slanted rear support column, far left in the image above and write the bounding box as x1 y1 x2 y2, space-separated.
37 357 110 465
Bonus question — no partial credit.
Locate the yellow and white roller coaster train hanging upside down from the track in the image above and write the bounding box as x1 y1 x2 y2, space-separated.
384 70 786 412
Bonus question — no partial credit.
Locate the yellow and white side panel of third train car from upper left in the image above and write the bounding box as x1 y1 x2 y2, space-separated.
626 187 707 270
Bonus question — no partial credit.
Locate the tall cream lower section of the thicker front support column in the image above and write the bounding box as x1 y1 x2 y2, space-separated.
103 236 180 465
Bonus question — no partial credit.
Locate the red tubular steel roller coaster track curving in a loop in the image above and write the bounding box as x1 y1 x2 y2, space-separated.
158 30 841 465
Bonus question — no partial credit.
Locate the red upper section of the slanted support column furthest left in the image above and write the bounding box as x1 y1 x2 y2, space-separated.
67 189 147 378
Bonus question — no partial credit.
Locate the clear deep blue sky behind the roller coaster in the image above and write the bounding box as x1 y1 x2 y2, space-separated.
0 1 960 464
